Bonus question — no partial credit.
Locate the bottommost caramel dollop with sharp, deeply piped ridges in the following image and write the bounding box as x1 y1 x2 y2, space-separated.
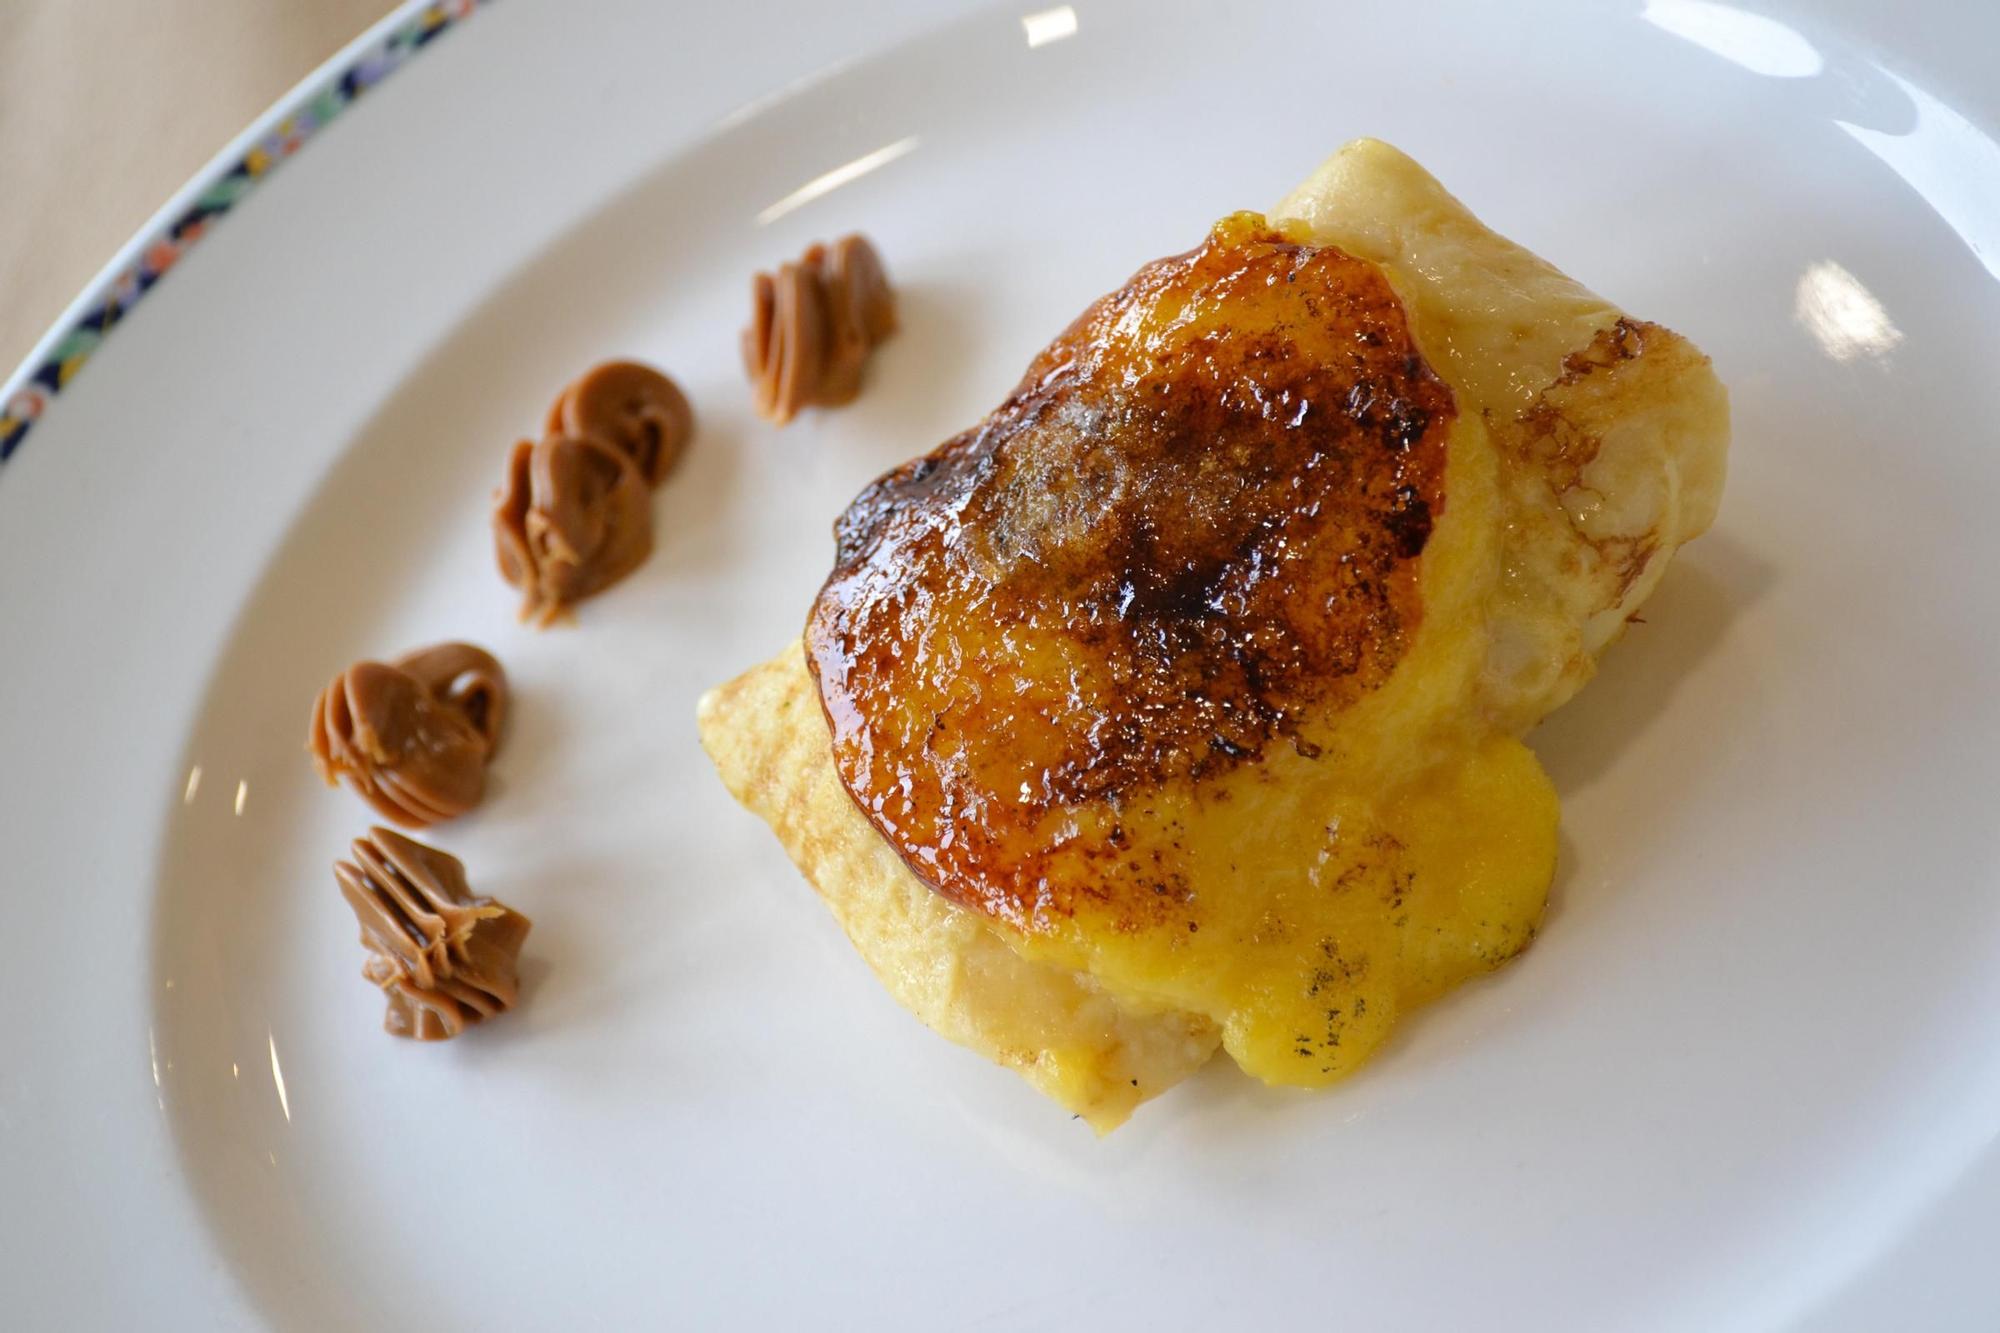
334 827 532 1041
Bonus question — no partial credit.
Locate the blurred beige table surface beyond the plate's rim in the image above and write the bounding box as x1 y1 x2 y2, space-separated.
0 0 394 378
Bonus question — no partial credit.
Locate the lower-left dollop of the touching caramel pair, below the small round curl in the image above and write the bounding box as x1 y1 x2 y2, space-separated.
492 434 652 626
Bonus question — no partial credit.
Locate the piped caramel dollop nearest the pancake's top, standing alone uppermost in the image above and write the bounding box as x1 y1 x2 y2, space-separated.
742 234 896 426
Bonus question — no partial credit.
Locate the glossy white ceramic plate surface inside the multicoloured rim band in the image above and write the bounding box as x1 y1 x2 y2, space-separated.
0 0 2000 1329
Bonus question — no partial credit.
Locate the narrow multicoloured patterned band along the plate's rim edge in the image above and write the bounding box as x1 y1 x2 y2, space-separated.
0 0 492 464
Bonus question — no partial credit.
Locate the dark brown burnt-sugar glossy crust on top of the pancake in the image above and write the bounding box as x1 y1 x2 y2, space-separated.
806 214 1454 929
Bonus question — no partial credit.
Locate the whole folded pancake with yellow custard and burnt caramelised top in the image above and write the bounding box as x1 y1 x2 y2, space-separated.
700 140 1728 1129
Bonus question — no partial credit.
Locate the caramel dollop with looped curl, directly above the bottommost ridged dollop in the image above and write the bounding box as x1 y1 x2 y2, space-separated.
306 642 506 829
